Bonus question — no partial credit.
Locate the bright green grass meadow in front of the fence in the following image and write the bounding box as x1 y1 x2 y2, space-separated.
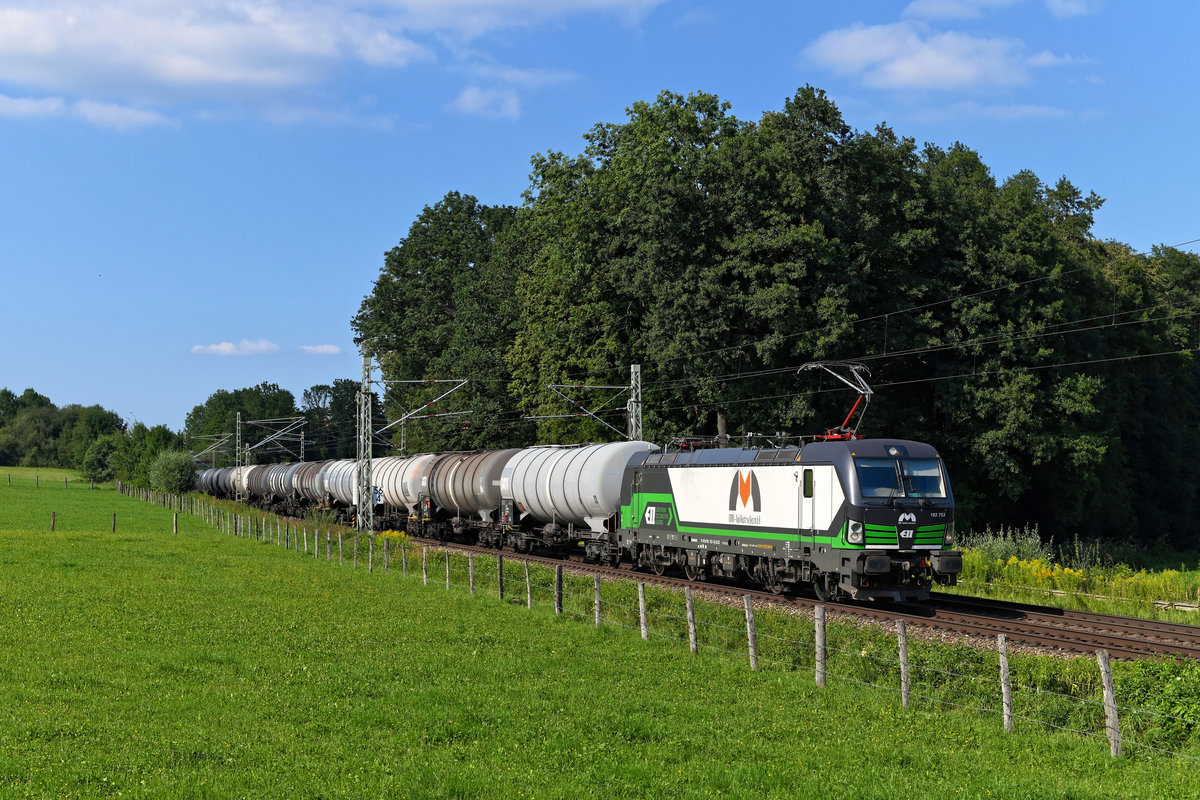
0 471 1200 800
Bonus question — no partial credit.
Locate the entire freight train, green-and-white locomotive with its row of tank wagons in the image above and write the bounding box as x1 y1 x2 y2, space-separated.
197 438 962 601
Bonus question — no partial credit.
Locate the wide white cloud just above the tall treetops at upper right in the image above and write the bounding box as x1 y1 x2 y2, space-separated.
805 23 1028 89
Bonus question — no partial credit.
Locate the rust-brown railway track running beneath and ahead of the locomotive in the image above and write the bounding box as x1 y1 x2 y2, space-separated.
414 539 1200 658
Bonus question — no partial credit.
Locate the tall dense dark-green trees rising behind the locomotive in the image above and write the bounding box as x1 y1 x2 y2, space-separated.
352 86 1200 546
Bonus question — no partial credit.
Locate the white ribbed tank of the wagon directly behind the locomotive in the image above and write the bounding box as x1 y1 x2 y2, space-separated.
500 441 658 533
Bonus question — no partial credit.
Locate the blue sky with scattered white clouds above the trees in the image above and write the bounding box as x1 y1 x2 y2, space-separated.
0 0 1200 429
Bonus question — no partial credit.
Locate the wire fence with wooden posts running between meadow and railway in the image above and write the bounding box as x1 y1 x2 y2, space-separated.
121 487 1200 763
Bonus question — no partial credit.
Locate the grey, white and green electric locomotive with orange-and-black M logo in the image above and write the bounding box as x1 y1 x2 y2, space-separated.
613 439 962 601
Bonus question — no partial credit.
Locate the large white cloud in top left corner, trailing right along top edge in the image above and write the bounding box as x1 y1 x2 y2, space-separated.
0 0 662 101
